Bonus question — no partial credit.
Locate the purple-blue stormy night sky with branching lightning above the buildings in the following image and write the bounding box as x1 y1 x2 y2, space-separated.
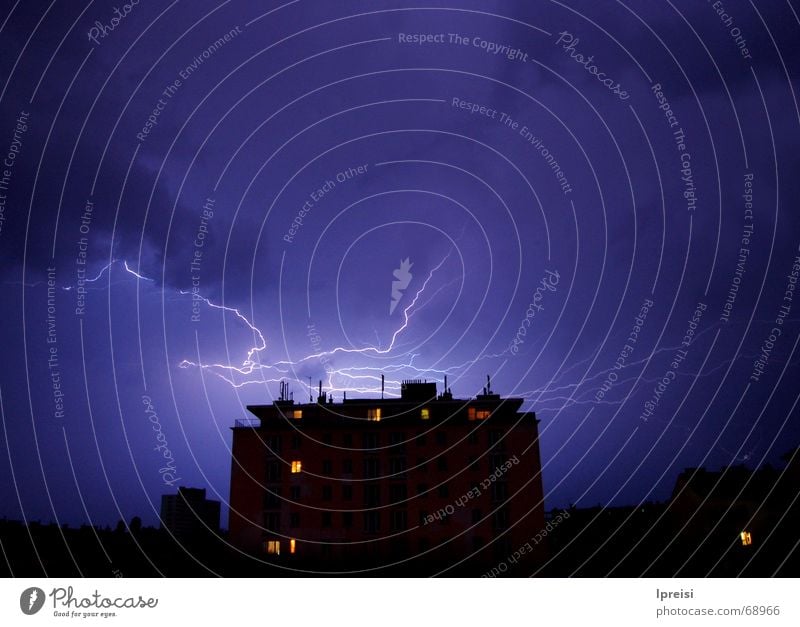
0 0 800 536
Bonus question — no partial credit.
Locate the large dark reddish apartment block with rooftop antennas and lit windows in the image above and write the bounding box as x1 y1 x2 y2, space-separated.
229 381 545 568
